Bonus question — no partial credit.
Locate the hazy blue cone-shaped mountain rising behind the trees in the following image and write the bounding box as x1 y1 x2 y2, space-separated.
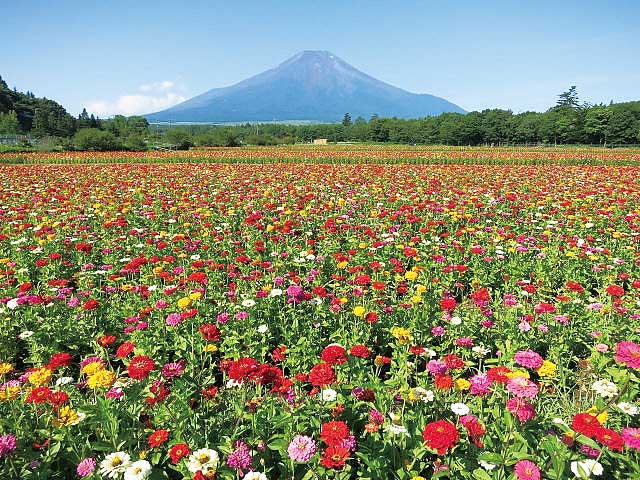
145 50 464 123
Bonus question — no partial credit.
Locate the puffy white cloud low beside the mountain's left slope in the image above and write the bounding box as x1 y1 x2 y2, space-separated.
84 80 187 117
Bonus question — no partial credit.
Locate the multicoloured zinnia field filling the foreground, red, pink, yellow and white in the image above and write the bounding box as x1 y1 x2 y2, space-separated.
0 157 640 480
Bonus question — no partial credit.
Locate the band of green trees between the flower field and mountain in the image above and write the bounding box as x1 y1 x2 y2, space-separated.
0 77 640 150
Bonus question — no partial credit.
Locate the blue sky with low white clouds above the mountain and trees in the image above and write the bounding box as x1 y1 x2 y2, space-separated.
0 0 640 117
